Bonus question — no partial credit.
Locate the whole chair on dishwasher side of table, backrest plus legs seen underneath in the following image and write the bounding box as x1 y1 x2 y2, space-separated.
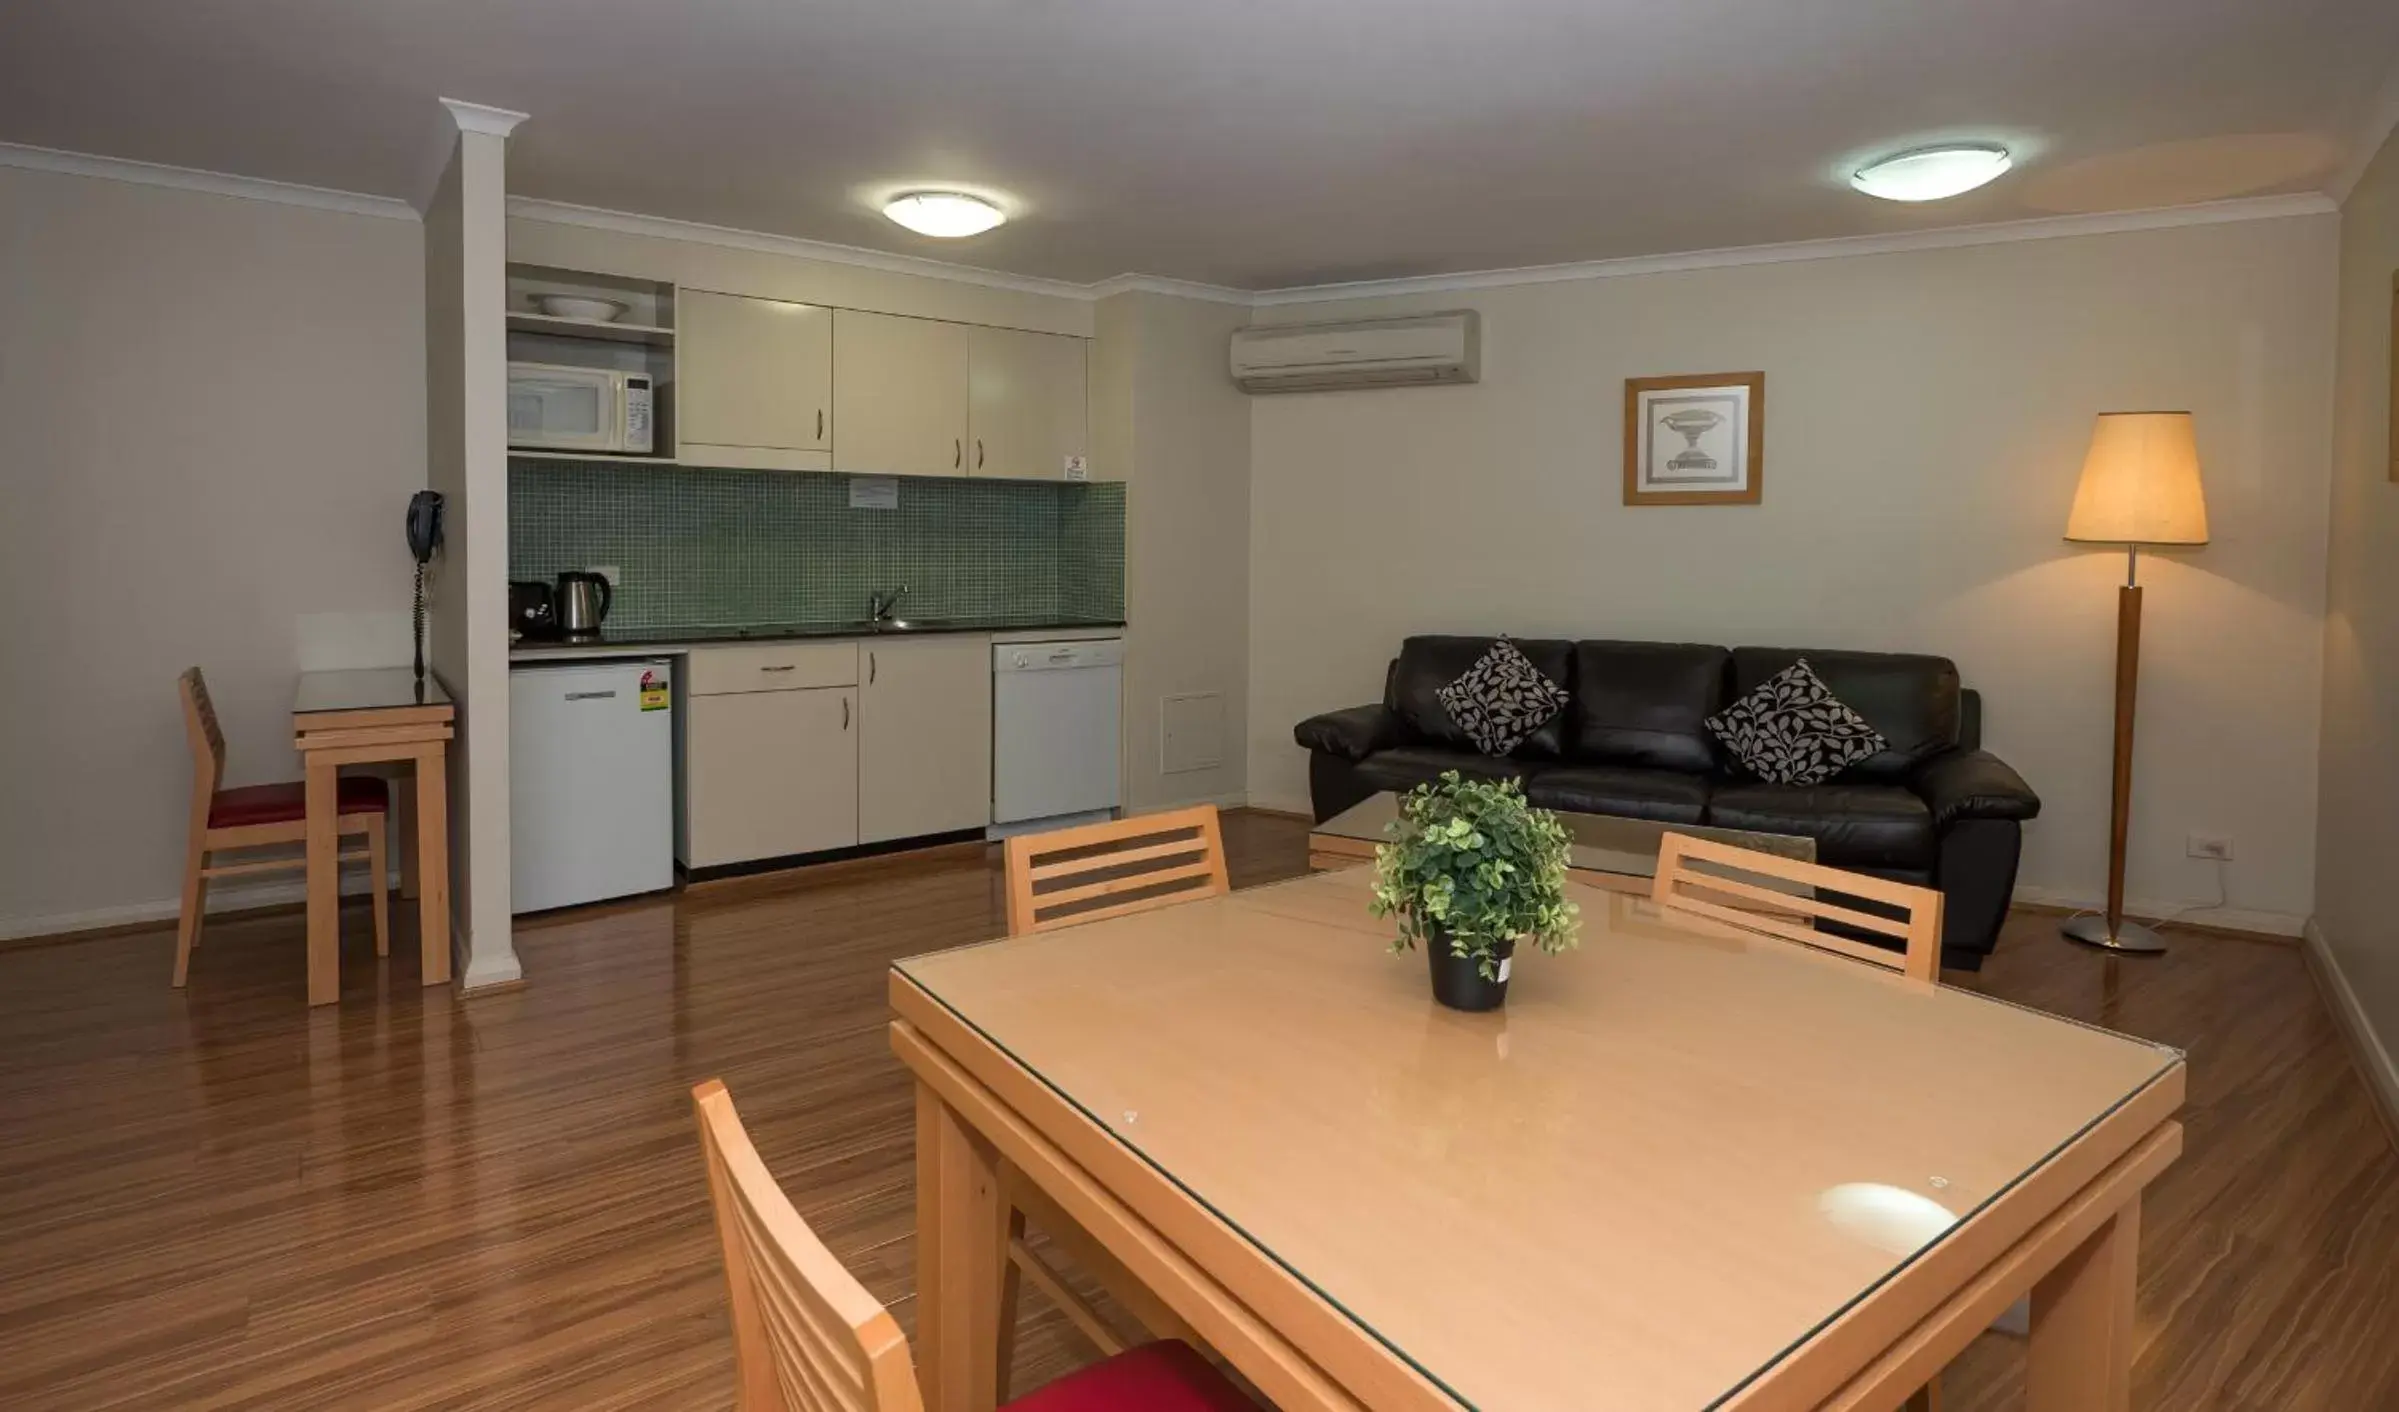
1000 803 1231 1381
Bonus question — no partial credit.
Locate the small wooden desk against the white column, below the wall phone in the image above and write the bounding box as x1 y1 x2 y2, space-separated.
293 666 458 1004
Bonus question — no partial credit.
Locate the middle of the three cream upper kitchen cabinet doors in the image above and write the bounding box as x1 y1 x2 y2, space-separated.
832 309 976 475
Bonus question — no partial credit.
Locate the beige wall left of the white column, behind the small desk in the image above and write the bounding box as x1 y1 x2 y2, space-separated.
0 168 425 934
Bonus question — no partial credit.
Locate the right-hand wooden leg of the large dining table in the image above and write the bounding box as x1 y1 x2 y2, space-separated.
2025 1196 2140 1412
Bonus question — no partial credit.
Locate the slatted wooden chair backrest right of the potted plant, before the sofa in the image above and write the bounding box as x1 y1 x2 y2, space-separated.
1651 834 1941 983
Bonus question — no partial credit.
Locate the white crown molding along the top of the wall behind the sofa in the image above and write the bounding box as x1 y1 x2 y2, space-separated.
1250 192 2339 307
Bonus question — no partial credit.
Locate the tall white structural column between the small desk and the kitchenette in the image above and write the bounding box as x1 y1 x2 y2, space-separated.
422 98 525 990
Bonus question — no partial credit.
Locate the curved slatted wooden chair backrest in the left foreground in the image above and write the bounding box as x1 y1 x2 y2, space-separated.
691 1079 924 1412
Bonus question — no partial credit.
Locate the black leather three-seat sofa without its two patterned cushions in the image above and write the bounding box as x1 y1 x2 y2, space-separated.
1293 638 2042 971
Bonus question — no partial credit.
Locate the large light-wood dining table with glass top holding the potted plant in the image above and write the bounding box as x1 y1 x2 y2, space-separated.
890 870 2185 1412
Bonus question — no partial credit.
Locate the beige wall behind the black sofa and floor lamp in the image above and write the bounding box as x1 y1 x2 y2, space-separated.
1250 216 2337 930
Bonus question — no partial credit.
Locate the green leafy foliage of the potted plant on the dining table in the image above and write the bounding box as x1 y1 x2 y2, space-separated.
1372 770 1581 980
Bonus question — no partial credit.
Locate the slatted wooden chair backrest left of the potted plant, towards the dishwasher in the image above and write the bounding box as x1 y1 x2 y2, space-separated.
1008 803 1231 937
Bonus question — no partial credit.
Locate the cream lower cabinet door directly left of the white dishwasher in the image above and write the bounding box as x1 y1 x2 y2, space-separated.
859 635 991 844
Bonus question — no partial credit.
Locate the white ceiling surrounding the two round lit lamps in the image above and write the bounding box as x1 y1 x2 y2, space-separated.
0 0 2399 288
